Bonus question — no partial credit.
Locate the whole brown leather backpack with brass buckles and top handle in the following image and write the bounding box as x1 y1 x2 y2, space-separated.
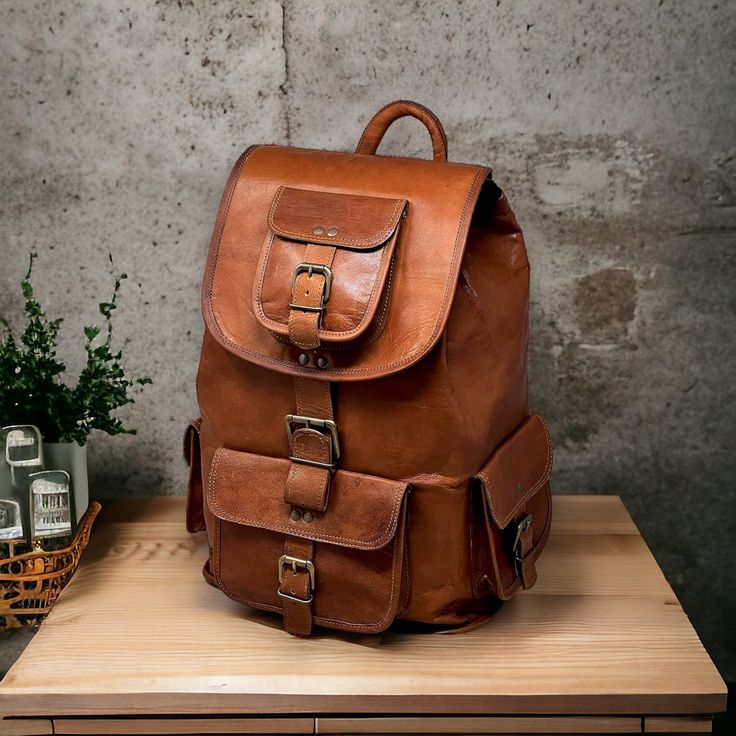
185 101 552 636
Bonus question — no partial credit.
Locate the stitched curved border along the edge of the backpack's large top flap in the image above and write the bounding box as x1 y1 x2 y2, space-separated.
204 167 489 380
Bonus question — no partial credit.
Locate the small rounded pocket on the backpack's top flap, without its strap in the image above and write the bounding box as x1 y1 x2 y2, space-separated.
253 187 407 343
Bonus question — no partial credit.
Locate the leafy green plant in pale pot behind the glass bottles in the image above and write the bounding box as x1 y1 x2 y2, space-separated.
0 253 151 541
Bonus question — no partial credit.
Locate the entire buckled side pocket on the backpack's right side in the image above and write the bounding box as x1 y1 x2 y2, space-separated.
471 414 552 600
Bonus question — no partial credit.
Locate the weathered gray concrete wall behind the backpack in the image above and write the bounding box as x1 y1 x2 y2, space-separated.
0 0 736 708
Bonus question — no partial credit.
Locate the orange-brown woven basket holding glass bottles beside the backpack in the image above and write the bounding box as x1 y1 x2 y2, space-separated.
0 501 102 629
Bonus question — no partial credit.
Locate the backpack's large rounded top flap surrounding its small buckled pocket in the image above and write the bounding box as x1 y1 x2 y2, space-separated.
202 146 490 381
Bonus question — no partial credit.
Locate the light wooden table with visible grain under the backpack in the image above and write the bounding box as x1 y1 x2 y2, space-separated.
0 496 726 734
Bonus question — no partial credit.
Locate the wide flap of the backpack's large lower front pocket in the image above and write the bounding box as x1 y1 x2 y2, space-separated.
207 448 408 549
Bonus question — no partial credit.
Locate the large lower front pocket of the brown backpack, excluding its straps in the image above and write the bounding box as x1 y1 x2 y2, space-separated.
207 448 408 632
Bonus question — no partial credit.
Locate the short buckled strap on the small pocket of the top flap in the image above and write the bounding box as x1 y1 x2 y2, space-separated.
289 243 337 350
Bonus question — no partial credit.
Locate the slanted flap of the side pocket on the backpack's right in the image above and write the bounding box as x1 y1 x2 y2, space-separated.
475 414 552 529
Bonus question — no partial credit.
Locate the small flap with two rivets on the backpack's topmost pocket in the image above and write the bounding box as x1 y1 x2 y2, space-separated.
268 186 406 250
